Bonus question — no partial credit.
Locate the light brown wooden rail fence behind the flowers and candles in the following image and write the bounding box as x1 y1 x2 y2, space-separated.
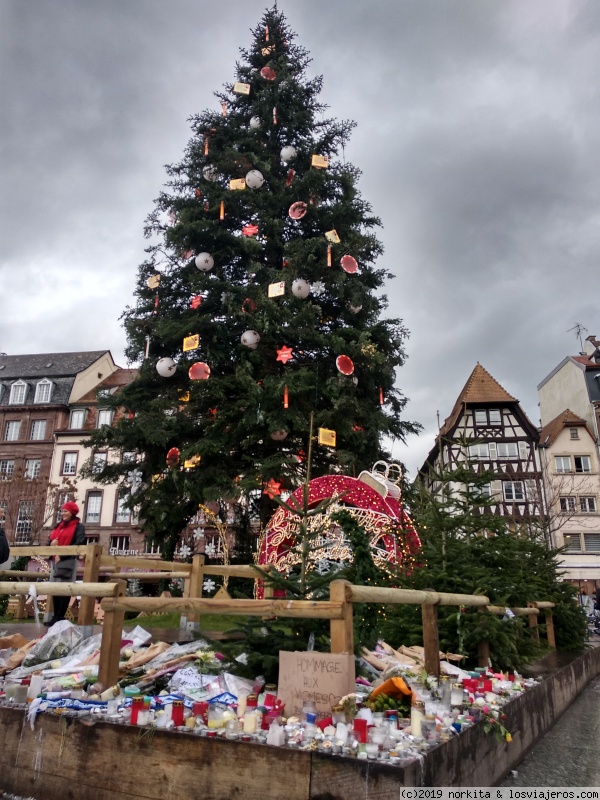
0 544 556 686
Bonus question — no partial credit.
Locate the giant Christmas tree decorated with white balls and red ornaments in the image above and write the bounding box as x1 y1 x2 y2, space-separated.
94 8 413 552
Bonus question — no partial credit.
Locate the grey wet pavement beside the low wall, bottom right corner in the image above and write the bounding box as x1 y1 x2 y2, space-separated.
500 678 600 787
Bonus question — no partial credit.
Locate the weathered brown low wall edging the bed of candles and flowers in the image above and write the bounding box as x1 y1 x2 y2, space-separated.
0 648 600 800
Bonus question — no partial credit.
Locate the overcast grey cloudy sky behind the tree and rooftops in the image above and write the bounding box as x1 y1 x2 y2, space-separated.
0 0 600 475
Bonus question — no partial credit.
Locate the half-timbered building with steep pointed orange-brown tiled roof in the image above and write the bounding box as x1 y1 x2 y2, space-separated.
420 363 545 533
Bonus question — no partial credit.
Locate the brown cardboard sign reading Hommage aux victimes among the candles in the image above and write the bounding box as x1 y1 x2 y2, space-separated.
277 650 354 717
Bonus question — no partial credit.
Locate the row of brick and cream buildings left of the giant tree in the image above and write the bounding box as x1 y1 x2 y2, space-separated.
0 350 143 551
